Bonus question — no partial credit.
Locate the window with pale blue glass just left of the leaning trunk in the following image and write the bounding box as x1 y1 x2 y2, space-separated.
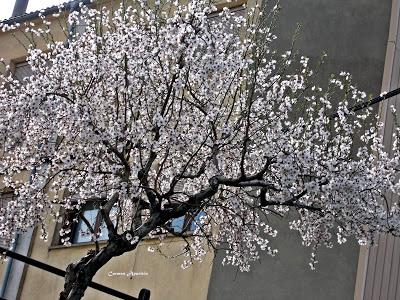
56 202 117 245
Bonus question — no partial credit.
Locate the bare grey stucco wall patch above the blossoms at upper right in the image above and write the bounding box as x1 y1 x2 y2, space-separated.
269 0 392 95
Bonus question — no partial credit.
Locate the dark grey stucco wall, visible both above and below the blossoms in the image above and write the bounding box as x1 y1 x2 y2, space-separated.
208 0 391 300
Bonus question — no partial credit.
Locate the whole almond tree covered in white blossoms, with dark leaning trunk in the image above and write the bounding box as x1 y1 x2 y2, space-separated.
0 0 400 299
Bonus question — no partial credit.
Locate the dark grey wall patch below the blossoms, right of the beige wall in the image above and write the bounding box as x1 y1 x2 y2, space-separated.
208 212 359 300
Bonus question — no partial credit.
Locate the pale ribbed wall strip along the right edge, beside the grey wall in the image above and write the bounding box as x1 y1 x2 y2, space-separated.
364 0 400 300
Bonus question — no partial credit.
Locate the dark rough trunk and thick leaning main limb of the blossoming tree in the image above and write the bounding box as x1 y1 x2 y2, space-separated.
59 175 320 300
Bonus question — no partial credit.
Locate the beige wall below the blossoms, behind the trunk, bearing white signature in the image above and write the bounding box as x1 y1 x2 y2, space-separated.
20 222 212 300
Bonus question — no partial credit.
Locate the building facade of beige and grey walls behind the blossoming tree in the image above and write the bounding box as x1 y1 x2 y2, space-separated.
0 0 400 300
